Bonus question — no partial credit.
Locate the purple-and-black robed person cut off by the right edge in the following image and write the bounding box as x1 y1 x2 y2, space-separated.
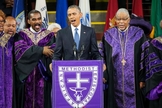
146 21 162 108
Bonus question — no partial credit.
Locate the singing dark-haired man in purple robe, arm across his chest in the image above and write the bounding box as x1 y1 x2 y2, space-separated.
15 10 55 108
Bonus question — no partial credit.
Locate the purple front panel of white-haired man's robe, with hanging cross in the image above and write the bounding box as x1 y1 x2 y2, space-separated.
105 26 147 108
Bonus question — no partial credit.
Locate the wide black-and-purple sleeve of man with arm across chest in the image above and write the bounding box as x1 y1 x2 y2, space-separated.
14 33 43 81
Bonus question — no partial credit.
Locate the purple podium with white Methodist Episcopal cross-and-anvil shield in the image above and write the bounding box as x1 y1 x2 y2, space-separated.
52 60 103 108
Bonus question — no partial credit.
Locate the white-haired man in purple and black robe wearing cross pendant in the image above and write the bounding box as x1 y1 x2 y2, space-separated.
100 8 149 108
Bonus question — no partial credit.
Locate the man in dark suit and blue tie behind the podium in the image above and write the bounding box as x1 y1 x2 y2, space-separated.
53 5 101 60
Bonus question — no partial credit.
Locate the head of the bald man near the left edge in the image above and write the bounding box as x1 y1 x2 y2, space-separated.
4 16 16 35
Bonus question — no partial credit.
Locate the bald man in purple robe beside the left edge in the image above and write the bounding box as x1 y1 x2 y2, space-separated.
0 16 16 108
